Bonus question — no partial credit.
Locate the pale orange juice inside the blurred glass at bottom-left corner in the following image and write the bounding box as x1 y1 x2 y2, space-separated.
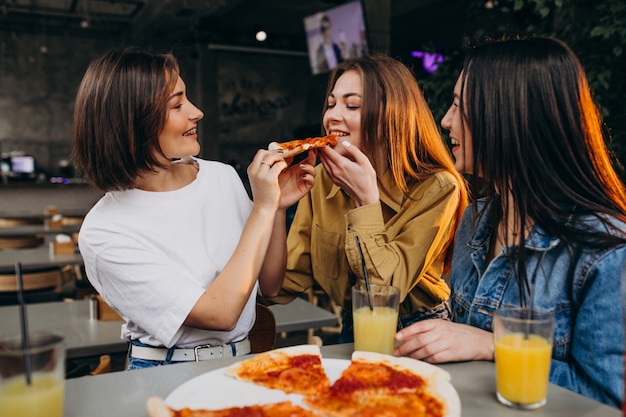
0 373 64 417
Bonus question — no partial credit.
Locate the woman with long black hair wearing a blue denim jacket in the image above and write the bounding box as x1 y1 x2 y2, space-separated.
396 38 626 407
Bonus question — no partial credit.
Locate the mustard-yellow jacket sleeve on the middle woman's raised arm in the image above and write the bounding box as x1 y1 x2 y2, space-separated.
345 177 460 299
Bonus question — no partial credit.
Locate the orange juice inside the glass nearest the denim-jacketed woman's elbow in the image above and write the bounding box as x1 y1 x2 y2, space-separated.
495 333 552 405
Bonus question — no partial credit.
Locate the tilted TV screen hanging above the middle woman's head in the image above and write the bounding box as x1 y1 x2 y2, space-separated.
304 0 368 74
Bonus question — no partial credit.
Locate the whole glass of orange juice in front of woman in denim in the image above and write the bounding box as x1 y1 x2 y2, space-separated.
493 307 554 410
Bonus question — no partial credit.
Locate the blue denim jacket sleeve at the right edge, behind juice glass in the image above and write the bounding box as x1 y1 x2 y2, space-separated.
550 246 626 408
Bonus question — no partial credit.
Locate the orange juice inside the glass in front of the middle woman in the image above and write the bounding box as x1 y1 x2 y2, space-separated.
353 306 398 355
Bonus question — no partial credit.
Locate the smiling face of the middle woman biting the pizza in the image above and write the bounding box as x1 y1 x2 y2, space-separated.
323 71 363 149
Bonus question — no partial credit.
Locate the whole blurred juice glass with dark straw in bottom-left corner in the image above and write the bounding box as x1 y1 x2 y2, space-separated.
0 332 65 417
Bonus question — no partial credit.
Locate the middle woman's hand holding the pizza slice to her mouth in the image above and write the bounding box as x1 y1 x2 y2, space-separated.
320 141 380 207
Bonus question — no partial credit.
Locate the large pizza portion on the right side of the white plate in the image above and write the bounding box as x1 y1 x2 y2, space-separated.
304 352 461 417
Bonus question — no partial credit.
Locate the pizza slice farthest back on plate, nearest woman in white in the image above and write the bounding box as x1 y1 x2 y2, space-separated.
226 345 330 395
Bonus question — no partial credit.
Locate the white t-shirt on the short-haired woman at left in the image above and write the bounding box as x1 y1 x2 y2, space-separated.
78 160 258 347
